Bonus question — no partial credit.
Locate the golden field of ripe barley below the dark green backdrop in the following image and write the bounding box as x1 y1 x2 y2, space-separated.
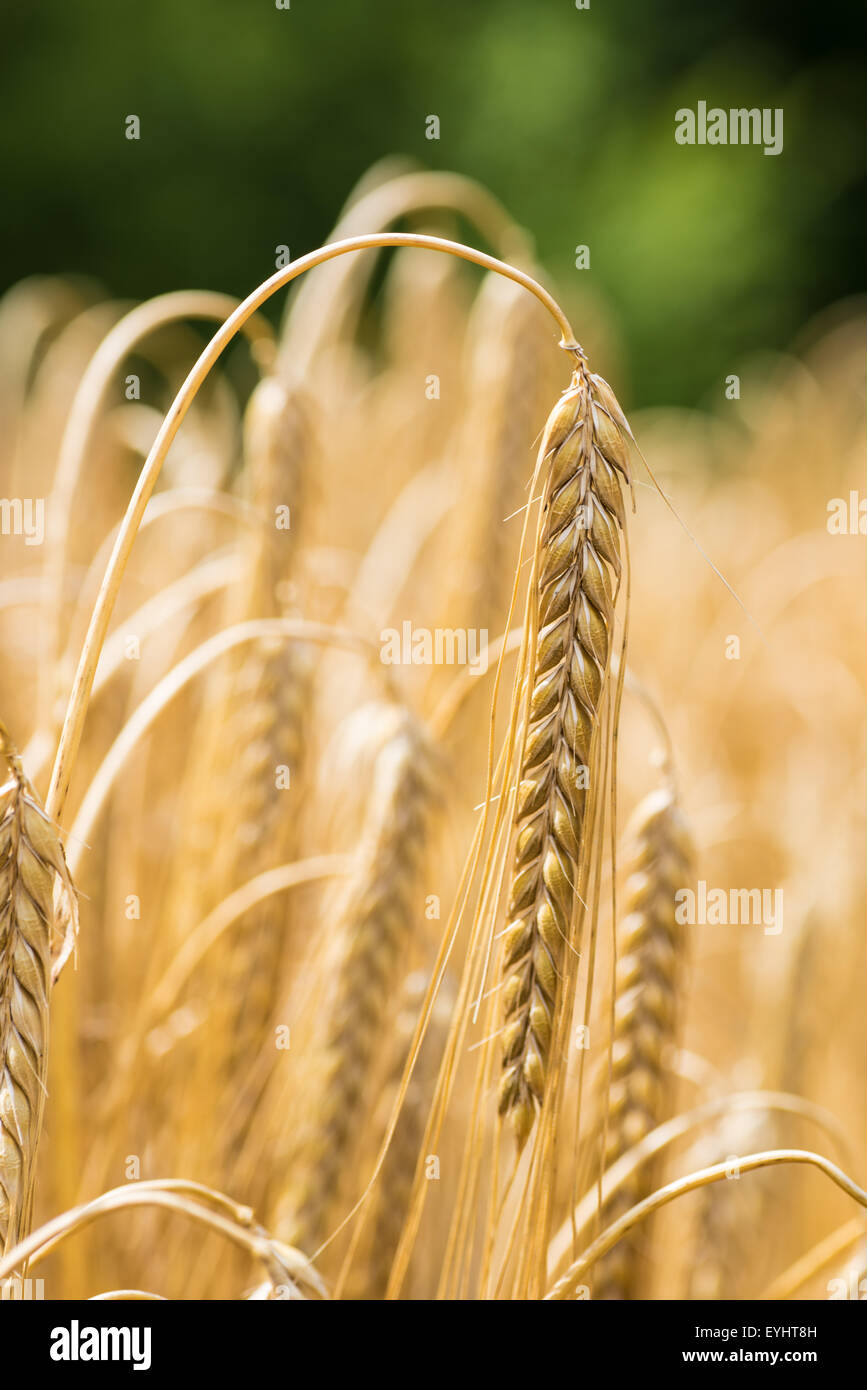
0 168 867 1301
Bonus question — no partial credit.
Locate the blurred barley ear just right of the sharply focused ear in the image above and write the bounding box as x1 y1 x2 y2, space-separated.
595 783 692 1298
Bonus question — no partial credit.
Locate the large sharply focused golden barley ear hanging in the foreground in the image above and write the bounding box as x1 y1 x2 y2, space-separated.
499 359 629 1145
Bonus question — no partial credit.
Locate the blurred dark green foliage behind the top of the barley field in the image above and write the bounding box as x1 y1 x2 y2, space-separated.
0 0 867 404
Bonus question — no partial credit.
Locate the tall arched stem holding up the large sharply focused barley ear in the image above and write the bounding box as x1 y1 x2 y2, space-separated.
46 232 581 821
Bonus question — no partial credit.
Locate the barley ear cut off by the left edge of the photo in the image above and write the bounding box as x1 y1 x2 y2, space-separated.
0 724 75 1252
